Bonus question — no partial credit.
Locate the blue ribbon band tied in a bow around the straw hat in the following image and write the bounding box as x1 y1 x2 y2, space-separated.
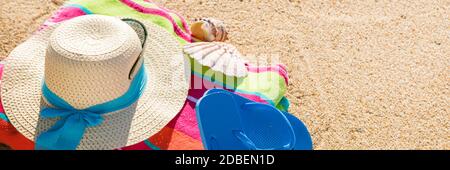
35 65 147 150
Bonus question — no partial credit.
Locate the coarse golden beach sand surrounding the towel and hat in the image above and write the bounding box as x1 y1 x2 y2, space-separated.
0 0 450 149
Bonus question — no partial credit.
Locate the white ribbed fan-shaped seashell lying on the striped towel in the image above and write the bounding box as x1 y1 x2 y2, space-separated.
184 42 248 77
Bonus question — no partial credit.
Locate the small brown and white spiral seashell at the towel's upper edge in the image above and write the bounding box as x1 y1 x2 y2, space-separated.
191 18 228 42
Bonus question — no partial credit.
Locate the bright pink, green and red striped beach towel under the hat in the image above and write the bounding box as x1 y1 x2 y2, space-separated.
0 0 289 150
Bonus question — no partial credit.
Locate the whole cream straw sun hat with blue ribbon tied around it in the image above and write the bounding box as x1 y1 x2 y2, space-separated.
1 15 189 149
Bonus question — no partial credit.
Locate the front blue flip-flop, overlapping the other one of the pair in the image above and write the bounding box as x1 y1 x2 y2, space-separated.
196 89 297 150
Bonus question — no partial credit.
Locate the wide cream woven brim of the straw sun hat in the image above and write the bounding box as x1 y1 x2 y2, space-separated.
1 16 190 150
